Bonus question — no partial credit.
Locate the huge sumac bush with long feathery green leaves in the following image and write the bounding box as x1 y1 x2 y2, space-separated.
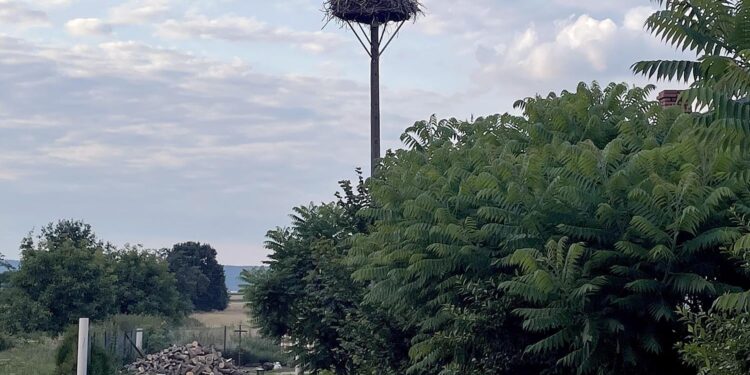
350 84 750 374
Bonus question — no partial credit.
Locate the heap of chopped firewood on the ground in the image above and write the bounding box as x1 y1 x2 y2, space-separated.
126 341 245 375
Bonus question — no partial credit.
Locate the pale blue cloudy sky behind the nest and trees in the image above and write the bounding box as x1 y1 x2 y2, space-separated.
0 0 692 265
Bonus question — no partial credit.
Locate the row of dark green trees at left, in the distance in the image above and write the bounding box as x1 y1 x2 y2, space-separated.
0 220 229 334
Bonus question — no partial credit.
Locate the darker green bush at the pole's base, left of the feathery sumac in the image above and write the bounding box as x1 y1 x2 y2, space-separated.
242 175 408 374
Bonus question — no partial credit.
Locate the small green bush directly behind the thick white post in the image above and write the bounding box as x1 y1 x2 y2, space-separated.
55 326 117 375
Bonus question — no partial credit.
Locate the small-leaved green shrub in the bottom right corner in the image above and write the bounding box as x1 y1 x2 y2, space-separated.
677 309 750 375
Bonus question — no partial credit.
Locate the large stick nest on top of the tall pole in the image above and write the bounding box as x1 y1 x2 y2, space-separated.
323 0 422 25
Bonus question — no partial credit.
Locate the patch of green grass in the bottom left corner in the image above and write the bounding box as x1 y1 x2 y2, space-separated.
0 338 58 375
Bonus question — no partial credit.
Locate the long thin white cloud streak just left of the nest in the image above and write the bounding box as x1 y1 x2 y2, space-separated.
157 14 350 52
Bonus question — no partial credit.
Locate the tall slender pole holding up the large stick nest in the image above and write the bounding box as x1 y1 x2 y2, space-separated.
370 22 380 176
